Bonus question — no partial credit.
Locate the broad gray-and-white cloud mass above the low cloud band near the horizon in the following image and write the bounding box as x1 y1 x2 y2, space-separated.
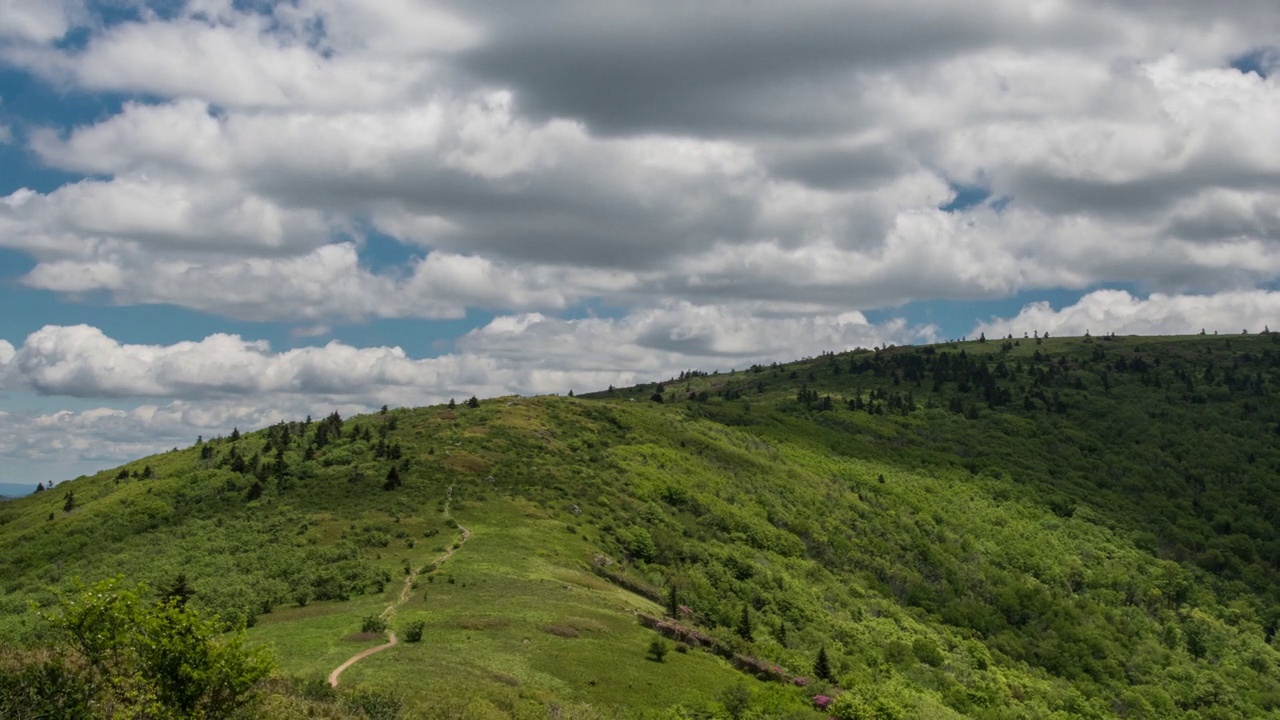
0 0 1280 317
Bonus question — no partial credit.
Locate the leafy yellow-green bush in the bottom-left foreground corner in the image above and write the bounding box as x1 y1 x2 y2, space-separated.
0 579 273 720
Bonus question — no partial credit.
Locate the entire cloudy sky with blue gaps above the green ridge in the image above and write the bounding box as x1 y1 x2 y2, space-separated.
0 0 1280 483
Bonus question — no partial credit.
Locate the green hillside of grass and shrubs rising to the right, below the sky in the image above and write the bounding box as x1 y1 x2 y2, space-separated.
0 334 1280 719
